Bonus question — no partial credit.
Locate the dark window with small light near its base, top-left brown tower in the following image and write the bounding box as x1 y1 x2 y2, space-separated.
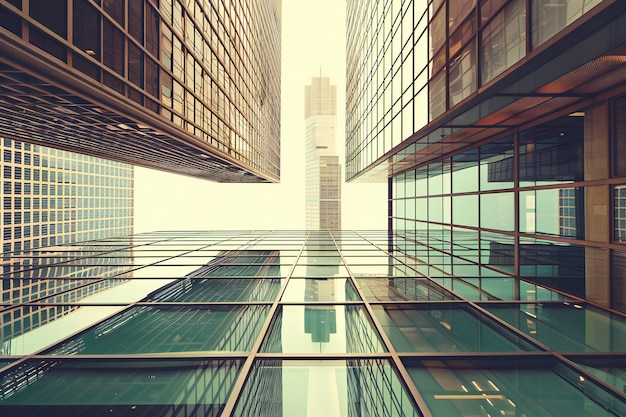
72 1 101 61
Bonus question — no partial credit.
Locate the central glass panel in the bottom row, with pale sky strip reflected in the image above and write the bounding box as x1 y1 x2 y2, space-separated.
234 359 422 417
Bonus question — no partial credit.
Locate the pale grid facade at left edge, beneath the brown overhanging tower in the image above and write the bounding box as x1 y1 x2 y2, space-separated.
0 139 133 257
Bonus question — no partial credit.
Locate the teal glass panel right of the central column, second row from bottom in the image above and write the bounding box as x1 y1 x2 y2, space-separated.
372 305 530 352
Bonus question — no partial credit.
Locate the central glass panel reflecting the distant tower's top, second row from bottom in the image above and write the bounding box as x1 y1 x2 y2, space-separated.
261 305 385 353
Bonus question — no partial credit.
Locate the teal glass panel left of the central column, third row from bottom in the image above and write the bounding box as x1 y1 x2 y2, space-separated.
148 278 281 303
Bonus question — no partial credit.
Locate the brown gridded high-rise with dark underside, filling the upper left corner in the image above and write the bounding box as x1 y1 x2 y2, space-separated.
0 0 281 182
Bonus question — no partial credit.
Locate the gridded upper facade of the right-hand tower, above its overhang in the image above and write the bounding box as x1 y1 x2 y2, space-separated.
346 0 623 181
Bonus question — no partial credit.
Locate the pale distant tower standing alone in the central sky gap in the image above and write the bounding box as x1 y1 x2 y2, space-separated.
304 77 342 230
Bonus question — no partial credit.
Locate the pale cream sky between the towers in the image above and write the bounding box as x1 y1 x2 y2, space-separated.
135 0 387 233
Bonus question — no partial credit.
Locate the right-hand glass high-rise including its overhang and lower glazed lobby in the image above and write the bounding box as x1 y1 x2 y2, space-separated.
346 0 626 314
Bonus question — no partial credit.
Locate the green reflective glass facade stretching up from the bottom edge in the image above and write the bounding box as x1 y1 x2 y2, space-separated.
0 231 626 417
